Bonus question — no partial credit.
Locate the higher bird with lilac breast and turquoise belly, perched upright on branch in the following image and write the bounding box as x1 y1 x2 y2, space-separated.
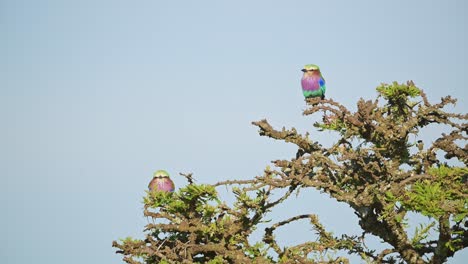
301 64 326 99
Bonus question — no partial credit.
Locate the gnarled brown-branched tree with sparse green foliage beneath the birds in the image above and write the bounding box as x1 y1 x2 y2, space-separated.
113 81 468 263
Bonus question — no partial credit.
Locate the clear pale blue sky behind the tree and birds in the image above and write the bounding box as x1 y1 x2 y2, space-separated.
0 0 468 263
